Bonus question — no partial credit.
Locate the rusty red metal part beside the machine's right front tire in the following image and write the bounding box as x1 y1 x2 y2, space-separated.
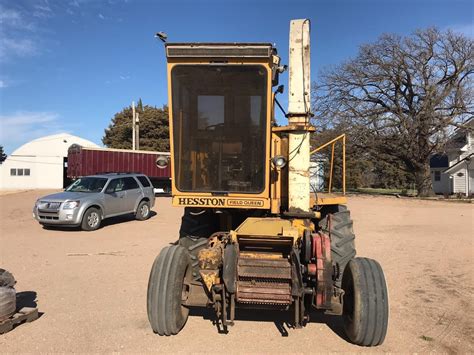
308 233 333 308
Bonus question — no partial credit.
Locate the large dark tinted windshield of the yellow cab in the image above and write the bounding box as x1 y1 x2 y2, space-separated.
171 65 267 193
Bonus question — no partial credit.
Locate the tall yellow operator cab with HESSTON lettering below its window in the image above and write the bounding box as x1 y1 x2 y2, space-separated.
166 43 280 207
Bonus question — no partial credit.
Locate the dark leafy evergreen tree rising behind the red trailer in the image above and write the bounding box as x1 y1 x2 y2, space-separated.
102 99 170 151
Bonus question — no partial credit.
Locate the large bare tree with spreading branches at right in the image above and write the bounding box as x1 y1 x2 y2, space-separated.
314 28 474 196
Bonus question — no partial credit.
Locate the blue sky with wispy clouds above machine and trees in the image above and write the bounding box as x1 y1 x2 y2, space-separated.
0 0 474 153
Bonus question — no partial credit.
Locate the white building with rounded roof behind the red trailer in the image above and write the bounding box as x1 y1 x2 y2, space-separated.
0 133 98 189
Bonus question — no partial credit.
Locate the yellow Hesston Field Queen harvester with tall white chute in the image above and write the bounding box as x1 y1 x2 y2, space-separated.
147 19 388 346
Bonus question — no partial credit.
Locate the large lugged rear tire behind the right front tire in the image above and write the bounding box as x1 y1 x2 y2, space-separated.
319 205 356 287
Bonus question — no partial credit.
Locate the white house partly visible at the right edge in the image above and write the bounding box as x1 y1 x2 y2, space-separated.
430 118 474 196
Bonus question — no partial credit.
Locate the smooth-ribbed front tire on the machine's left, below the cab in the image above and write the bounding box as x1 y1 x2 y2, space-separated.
147 245 189 335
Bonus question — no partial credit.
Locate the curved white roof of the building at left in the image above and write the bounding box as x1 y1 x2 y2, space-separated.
9 133 99 157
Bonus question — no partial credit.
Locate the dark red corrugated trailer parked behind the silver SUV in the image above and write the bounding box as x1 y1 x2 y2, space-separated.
67 145 171 179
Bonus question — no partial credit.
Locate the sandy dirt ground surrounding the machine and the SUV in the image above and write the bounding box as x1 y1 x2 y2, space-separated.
0 191 474 353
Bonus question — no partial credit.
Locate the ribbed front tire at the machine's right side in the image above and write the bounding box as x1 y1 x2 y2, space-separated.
342 258 388 346
